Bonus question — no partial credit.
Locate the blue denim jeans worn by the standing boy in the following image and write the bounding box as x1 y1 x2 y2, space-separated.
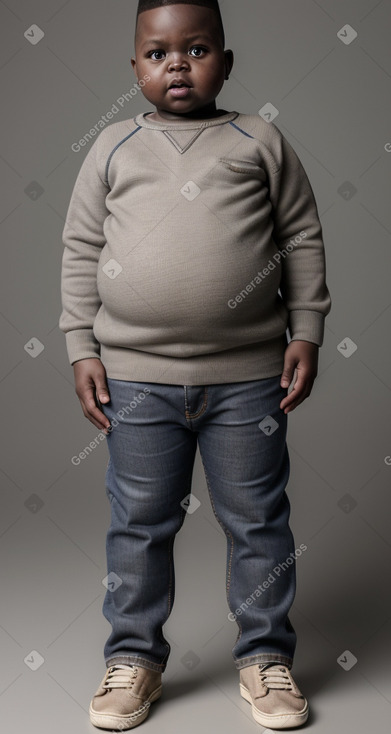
102 376 296 672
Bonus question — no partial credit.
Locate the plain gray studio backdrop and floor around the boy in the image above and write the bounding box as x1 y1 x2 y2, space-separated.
0 0 391 734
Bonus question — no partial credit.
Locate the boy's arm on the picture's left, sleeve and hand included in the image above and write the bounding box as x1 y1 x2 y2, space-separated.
59 141 110 429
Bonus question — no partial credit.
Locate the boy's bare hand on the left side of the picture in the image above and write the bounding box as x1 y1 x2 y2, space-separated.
73 357 110 433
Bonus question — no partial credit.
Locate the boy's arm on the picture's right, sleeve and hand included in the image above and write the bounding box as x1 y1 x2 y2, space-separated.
270 133 331 413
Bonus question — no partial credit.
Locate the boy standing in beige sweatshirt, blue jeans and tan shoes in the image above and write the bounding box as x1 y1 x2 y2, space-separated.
60 0 331 730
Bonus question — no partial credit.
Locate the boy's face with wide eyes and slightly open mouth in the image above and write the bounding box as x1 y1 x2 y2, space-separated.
131 3 233 121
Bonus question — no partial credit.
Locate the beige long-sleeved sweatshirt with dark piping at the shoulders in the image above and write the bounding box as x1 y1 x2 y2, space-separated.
59 111 331 385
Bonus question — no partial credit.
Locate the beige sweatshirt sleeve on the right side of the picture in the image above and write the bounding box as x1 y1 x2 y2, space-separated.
269 126 331 346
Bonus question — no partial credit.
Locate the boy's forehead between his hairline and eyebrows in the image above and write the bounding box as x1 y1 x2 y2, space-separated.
136 3 217 44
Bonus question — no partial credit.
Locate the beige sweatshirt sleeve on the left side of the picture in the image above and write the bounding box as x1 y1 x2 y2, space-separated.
59 138 110 364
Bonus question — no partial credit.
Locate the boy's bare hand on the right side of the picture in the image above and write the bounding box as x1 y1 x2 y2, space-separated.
280 339 319 413
